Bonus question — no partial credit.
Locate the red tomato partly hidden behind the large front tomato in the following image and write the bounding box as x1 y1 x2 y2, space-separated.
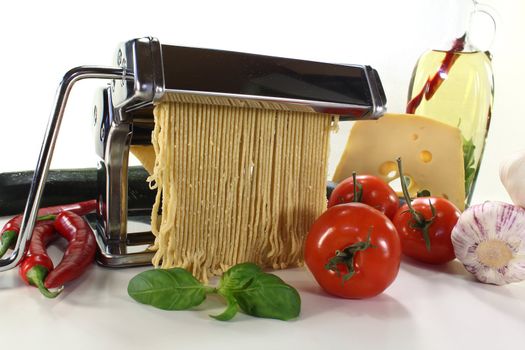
328 175 399 219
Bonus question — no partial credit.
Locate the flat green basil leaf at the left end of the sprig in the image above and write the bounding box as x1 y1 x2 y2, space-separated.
128 268 208 310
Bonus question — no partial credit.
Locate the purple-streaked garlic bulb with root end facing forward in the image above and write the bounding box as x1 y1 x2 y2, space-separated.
452 202 525 285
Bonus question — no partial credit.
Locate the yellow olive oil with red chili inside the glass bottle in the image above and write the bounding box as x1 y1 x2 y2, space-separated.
407 50 494 205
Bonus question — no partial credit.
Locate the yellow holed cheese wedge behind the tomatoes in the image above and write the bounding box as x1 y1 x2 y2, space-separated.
333 114 465 210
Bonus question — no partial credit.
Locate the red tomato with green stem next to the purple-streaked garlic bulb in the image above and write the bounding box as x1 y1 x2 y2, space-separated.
392 197 461 264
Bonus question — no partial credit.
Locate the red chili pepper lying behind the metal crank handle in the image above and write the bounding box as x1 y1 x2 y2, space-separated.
0 199 97 257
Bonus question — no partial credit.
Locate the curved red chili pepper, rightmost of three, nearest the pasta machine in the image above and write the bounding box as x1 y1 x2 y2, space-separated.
44 211 97 288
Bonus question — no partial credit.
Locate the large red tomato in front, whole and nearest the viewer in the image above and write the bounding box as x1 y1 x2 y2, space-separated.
304 203 401 299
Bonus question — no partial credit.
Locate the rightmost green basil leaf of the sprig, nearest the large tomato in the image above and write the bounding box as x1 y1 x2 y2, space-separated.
232 272 301 320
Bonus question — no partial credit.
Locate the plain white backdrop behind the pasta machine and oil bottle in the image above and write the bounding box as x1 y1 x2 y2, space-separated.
0 0 525 202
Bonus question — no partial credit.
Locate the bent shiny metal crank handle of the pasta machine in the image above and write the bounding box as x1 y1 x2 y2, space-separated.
0 66 133 272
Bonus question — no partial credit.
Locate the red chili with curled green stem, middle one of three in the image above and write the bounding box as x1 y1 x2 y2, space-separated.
19 221 62 298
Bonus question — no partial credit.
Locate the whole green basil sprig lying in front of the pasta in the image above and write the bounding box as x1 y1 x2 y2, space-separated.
128 263 301 321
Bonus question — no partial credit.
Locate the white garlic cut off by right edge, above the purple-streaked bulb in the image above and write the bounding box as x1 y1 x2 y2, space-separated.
499 150 525 208
